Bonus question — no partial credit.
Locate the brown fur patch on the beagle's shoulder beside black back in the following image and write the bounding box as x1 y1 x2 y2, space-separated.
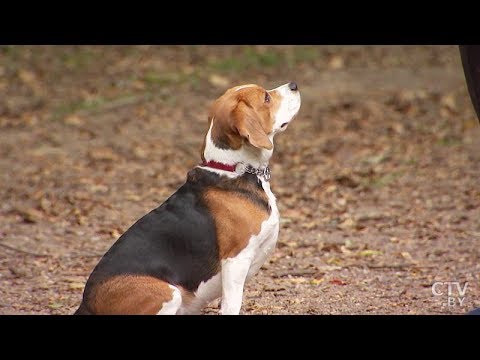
204 188 269 259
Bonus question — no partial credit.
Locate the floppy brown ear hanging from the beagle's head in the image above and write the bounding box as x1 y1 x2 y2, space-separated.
233 101 273 150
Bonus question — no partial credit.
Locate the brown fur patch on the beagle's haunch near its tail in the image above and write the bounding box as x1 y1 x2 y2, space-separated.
88 275 173 315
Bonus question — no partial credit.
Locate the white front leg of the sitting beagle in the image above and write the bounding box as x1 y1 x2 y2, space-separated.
220 258 252 315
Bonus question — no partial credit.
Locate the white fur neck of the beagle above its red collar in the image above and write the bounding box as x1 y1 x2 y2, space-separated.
203 121 274 169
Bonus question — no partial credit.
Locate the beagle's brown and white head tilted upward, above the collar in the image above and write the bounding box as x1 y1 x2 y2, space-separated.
202 83 301 165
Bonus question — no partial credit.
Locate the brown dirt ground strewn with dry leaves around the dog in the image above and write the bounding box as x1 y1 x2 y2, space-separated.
0 46 480 314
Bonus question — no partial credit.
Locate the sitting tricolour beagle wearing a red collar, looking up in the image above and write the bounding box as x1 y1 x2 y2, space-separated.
75 82 301 315
